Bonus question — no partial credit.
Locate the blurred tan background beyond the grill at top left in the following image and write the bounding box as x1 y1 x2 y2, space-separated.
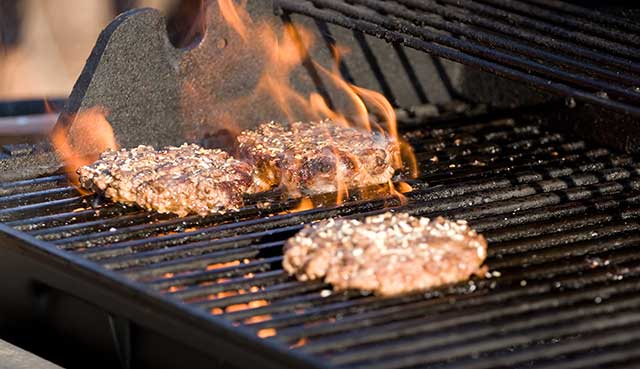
0 0 179 100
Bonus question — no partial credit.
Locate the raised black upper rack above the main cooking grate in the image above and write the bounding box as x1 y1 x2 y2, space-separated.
276 0 640 116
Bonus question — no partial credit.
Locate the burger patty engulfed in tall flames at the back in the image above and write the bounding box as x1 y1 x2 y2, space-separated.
238 120 399 196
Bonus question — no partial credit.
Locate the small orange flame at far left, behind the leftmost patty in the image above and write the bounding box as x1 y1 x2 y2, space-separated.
51 107 118 186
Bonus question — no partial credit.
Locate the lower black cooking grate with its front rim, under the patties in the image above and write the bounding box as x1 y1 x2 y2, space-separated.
0 105 640 368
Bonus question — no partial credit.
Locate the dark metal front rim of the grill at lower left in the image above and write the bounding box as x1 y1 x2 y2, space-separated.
0 224 325 369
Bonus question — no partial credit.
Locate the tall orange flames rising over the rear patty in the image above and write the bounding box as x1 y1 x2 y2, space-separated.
218 0 418 204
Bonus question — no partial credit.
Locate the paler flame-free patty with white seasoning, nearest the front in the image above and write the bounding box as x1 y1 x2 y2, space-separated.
283 213 487 296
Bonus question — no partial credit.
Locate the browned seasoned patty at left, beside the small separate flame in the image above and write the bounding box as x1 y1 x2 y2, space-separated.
78 144 252 216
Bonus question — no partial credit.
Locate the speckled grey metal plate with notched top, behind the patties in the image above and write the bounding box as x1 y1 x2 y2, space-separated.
57 1 315 147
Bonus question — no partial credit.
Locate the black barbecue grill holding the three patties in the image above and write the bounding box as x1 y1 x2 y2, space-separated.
0 0 640 368
